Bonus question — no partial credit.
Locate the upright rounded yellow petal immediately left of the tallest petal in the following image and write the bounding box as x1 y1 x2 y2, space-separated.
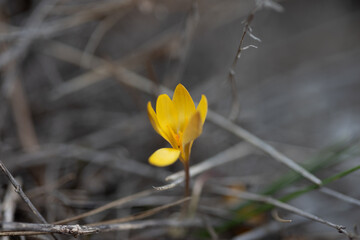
156 94 178 133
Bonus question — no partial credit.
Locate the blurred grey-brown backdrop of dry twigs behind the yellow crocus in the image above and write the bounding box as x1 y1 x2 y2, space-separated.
0 0 360 240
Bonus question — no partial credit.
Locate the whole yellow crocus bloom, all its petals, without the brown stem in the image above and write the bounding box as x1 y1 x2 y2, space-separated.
147 84 208 167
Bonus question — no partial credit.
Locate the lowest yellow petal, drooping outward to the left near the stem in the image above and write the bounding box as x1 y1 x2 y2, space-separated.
149 148 180 167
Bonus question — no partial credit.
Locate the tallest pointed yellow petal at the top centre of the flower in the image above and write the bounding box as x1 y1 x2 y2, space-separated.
173 84 195 131
